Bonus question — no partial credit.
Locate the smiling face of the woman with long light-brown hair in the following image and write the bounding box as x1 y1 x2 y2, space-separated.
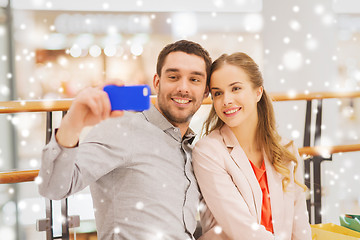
210 64 263 128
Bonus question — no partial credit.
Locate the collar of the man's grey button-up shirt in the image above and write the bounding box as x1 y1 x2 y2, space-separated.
142 104 195 144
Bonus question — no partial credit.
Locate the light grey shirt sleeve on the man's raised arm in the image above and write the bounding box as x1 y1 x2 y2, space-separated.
38 117 131 200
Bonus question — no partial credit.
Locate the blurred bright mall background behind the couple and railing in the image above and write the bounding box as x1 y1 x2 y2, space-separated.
0 0 360 240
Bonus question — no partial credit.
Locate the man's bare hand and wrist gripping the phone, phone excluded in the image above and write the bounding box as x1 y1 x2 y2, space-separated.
56 81 124 147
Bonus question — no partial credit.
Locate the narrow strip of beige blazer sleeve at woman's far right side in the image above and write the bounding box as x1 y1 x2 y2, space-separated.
291 146 311 240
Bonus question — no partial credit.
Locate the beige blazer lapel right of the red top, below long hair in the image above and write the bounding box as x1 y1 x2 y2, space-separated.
264 153 285 233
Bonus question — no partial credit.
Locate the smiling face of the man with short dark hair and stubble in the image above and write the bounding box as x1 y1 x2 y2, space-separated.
154 51 208 126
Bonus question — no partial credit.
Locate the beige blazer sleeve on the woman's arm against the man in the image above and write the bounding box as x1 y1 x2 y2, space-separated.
193 139 274 240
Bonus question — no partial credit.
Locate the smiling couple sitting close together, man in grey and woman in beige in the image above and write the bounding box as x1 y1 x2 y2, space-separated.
39 40 310 240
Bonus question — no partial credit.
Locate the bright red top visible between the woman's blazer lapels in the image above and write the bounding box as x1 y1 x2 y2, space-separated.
250 161 274 233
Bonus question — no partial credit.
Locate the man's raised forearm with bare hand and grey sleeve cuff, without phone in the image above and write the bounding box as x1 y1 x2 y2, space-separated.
39 82 123 199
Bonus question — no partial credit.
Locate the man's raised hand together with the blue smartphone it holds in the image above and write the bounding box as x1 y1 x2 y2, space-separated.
56 81 151 147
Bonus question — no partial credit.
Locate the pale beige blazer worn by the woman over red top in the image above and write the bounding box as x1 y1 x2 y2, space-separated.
193 125 311 240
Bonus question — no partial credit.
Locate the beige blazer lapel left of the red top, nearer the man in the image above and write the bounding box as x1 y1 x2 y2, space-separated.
220 125 262 224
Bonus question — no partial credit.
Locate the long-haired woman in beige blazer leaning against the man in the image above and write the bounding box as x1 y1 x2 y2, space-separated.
193 53 311 240
